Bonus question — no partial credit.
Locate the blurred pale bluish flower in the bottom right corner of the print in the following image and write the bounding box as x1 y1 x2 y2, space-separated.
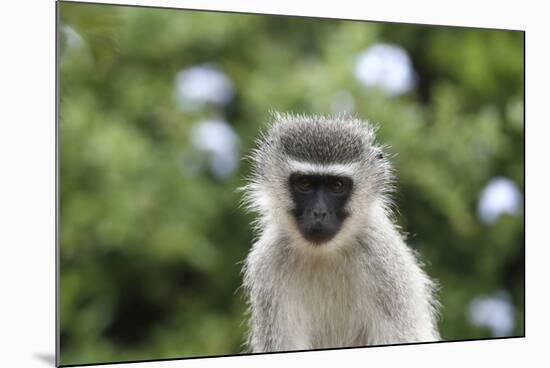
469 291 515 337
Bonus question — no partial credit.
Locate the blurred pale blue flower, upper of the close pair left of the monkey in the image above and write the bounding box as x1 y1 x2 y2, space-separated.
176 64 233 111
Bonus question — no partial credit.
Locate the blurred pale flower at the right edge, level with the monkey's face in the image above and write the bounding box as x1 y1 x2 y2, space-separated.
477 177 522 224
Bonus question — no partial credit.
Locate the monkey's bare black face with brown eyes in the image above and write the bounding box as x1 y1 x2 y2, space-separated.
289 173 353 244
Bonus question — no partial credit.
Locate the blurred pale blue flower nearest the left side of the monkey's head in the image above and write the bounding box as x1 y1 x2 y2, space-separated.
191 120 239 178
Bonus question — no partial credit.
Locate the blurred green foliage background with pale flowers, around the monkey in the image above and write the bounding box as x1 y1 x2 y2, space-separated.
58 3 524 364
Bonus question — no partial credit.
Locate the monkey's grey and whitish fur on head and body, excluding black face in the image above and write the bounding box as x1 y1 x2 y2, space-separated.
243 114 440 352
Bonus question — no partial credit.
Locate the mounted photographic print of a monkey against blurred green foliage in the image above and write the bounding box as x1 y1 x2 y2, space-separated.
57 2 525 366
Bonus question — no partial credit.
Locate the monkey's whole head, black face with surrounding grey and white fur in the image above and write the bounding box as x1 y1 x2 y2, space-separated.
245 114 392 250
